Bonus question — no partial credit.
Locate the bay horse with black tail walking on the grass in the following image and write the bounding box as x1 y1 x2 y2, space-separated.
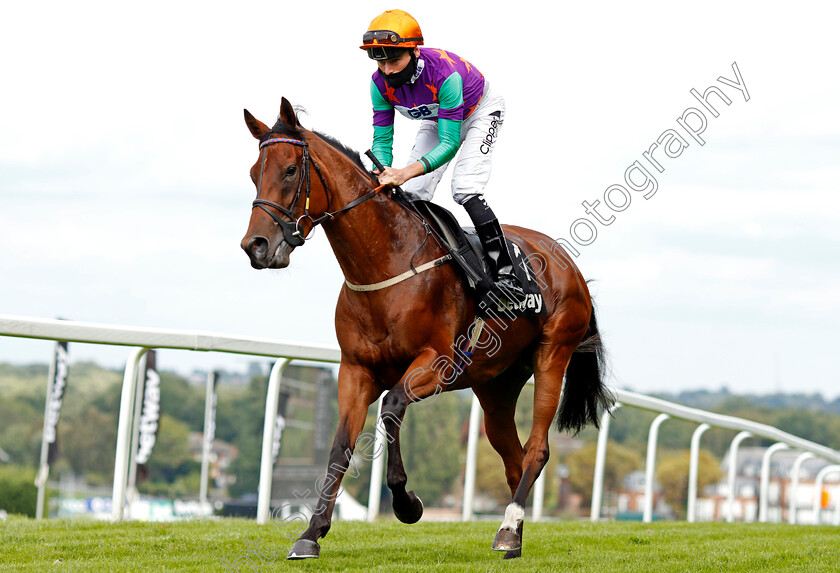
241 98 613 559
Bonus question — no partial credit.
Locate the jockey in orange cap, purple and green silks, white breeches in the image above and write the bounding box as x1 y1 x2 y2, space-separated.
360 10 523 294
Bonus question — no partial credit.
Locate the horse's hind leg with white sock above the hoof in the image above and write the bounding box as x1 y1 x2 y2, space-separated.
492 337 579 552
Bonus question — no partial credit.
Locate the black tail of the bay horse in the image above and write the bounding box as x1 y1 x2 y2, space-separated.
557 305 615 435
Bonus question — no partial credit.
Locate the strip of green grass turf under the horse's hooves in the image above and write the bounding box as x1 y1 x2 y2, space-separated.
0 517 840 573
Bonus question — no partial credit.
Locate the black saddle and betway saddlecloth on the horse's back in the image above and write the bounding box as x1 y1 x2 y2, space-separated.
410 200 546 318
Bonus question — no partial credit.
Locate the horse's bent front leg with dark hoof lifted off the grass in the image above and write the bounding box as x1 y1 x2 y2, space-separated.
382 349 444 523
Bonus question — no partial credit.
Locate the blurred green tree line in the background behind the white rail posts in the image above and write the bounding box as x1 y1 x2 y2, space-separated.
0 362 840 513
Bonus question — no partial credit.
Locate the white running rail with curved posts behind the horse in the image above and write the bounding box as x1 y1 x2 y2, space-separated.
0 314 840 523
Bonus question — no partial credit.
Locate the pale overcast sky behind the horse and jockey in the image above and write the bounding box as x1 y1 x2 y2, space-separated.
0 0 840 398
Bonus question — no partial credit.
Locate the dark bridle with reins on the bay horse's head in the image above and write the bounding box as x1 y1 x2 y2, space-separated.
251 137 385 248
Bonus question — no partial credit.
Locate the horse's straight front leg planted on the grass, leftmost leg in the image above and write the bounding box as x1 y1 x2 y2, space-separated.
286 363 377 559
